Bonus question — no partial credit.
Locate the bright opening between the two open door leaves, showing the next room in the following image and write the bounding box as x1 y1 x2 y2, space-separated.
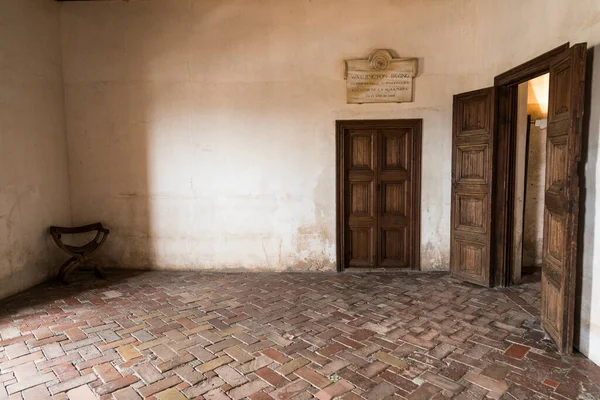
512 74 550 284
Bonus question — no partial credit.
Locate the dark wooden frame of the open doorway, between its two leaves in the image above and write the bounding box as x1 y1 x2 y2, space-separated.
492 43 570 286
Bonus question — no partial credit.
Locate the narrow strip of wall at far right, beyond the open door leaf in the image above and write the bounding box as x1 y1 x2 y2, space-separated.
575 46 600 353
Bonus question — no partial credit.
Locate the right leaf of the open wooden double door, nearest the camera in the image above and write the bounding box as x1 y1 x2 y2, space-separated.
541 43 587 354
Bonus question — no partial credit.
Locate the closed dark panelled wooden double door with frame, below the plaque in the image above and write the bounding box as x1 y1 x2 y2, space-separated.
338 120 421 269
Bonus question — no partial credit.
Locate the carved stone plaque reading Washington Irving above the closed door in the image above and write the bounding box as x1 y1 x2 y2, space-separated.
346 50 417 104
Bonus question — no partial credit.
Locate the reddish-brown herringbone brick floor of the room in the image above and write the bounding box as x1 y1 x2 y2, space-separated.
0 272 600 400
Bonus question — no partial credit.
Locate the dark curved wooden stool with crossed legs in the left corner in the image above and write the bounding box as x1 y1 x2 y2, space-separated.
50 222 110 283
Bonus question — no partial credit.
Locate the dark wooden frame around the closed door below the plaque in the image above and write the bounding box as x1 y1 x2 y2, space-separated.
335 118 423 272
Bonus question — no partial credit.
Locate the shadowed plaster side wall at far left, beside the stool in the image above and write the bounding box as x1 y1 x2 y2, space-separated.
0 0 70 298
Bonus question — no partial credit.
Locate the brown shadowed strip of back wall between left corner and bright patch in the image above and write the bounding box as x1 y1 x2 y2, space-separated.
62 2 157 270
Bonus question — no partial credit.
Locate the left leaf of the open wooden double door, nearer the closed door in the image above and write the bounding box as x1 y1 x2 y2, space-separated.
450 87 495 286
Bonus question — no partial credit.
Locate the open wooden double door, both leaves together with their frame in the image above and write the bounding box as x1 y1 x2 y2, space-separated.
450 43 587 354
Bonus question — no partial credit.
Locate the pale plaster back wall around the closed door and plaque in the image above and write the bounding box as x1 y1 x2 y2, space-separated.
62 0 600 270
